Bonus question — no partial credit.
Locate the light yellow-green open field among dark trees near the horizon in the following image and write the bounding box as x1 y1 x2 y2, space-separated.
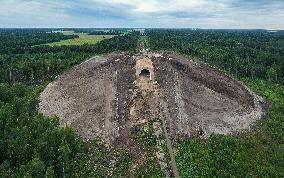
48 32 113 46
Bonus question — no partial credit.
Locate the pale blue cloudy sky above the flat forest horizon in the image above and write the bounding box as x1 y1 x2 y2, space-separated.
0 0 284 29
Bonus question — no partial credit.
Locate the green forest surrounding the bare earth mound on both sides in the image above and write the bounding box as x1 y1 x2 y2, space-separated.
0 29 284 178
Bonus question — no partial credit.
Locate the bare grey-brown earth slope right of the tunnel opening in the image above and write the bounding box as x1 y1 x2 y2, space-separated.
153 53 264 137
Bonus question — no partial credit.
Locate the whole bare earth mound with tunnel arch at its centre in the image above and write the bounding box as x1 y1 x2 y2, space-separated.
40 52 264 143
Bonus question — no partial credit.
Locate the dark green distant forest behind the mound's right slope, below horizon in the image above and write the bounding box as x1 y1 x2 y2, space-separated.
146 29 284 81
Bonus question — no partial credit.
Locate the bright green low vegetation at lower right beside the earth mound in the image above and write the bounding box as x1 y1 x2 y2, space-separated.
176 79 284 177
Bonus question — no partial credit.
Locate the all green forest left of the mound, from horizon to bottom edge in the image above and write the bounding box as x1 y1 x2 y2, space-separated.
0 30 138 178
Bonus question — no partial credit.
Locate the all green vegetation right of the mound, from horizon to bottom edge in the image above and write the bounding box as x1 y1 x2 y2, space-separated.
147 30 284 177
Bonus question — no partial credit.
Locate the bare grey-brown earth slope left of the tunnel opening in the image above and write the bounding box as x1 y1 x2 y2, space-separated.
40 54 135 143
